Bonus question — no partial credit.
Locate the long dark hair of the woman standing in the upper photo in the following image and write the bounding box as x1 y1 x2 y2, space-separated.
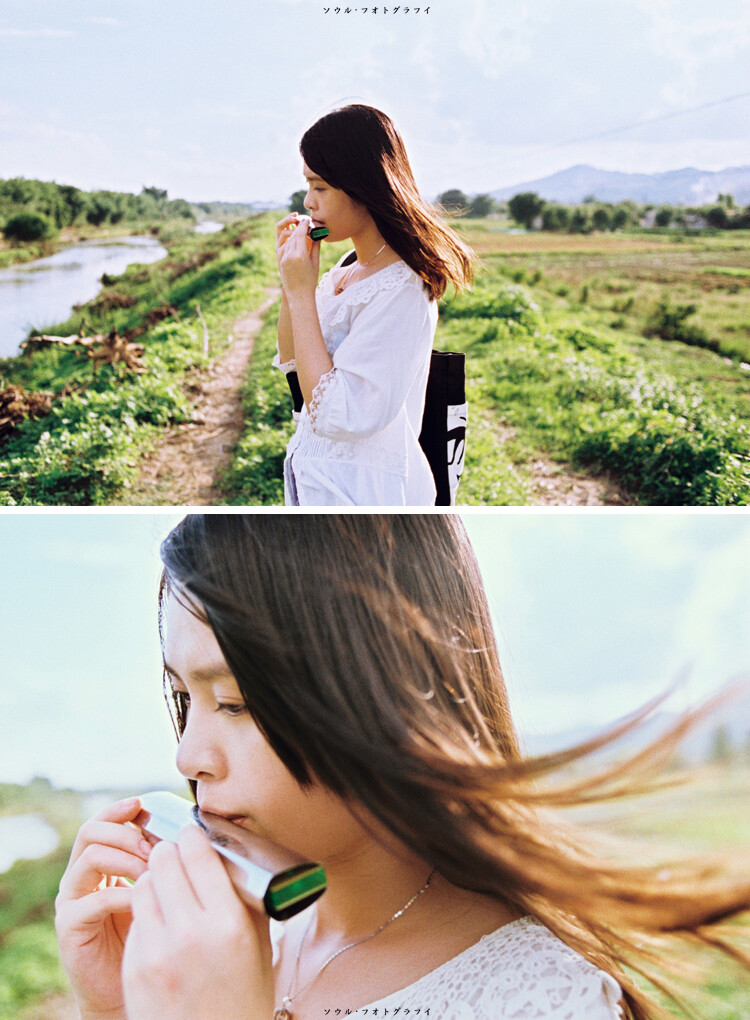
300 103 473 299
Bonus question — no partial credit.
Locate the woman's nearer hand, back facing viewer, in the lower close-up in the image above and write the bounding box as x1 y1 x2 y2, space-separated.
122 826 273 1020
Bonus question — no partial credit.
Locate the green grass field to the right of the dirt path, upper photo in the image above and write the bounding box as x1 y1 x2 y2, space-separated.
230 225 750 506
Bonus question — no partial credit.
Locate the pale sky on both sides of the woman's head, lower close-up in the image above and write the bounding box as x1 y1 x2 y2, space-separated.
0 510 750 788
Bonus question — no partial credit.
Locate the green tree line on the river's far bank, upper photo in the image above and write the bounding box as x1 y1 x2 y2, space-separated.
0 177 196 241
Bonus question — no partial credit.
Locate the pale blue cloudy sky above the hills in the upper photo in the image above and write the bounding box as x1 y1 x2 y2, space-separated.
0 0 750 202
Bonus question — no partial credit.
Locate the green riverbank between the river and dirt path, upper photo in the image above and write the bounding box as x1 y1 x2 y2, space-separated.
0 216 276 506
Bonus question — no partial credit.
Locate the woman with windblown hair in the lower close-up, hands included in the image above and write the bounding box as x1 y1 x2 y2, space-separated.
57 514 750 1020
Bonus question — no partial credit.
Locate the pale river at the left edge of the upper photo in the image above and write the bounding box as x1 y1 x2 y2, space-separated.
0 238 166 358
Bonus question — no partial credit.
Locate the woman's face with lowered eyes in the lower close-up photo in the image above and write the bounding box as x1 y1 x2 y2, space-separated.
163 595 369 863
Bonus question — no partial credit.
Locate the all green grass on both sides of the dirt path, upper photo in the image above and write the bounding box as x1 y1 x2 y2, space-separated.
0 213 750 506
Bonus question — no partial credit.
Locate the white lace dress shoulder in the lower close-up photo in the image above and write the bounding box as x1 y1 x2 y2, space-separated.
273 917 622 1020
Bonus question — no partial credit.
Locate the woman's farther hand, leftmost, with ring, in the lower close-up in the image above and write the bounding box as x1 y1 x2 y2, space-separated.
55 798 151 1020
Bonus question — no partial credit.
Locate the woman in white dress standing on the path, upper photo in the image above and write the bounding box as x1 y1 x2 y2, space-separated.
274 104 471 506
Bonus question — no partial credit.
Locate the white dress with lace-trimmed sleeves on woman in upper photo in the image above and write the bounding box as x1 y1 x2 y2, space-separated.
273 256 438 506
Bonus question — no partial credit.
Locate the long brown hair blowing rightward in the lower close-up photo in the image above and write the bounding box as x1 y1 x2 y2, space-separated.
160 514 750 1020
